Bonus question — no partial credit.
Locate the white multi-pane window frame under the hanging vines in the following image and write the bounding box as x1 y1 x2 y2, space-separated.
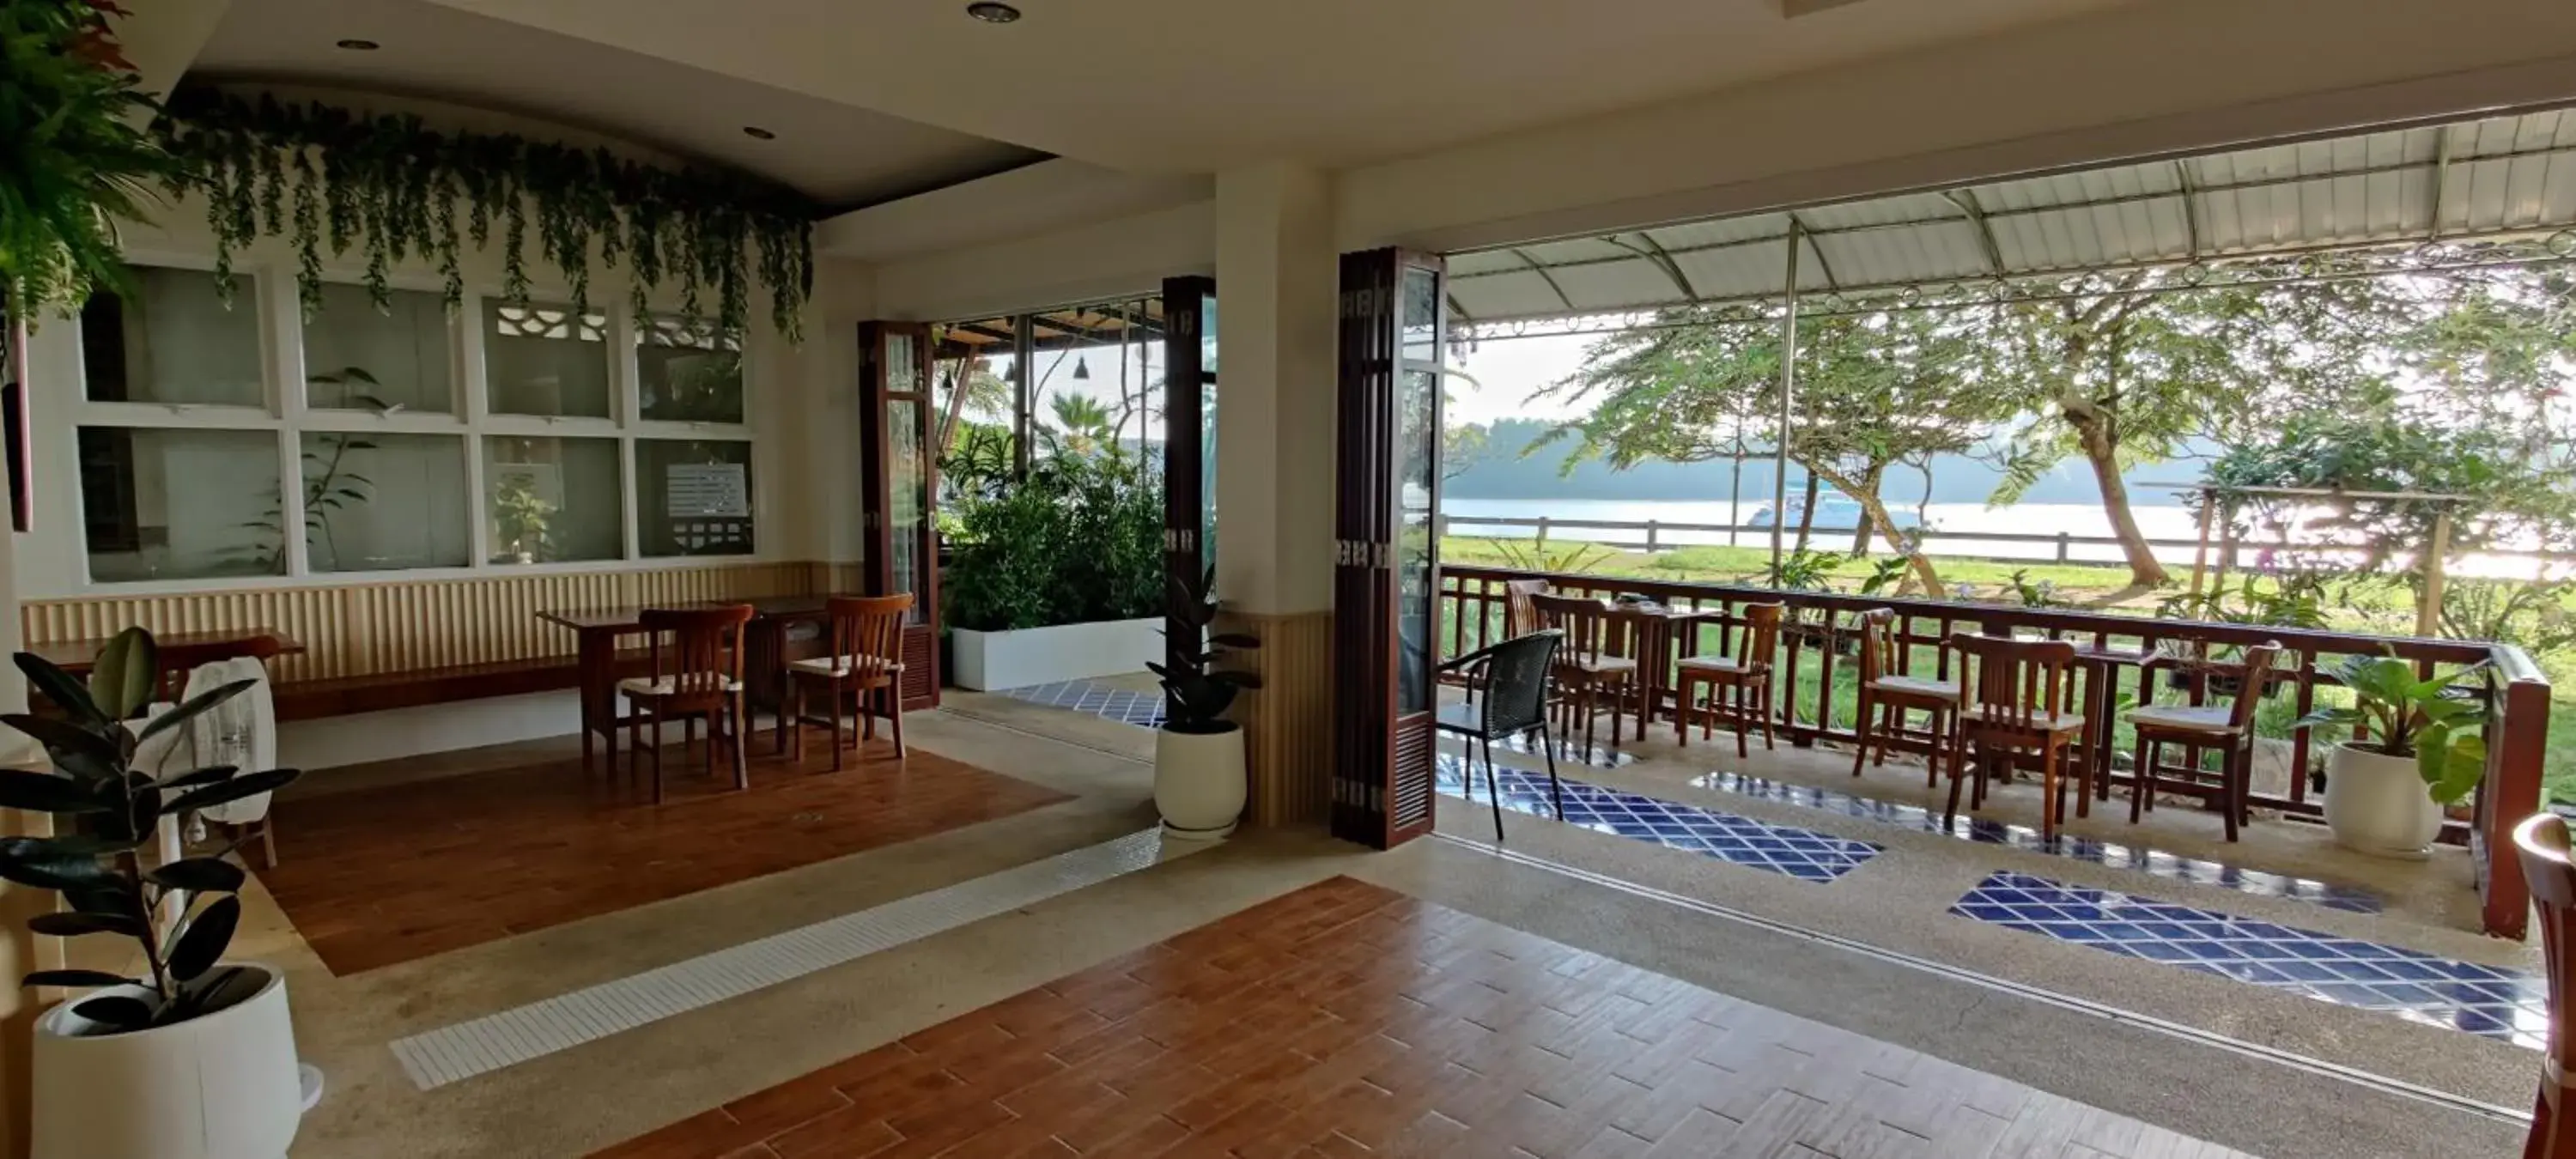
52 247 778 595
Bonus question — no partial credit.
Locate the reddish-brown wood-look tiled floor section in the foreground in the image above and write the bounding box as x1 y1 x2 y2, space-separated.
600 878 2233 1159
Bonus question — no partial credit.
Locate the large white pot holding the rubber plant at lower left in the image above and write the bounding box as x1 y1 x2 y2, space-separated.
31 966 304 1159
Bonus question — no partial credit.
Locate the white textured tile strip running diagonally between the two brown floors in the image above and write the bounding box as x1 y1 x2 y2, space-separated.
394 829 1162 1089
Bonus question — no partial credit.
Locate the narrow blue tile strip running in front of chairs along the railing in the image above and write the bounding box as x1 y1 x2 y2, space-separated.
1690 773 2385 914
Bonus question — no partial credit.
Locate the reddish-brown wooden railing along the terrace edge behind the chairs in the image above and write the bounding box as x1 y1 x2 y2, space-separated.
1437 567 2550 938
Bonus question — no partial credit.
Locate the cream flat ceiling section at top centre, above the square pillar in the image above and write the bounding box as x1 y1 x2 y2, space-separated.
412 0 2143 173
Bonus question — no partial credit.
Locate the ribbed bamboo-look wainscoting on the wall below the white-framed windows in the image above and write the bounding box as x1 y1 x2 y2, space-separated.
18 561 832 683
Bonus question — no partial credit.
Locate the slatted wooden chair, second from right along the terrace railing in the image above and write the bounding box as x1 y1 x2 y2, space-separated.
1945 631 2089 840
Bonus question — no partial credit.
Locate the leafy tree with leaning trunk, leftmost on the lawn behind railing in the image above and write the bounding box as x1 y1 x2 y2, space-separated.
1530 309 2009 590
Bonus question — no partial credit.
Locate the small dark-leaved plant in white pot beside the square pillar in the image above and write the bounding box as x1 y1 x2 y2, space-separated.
1146 574 1262 840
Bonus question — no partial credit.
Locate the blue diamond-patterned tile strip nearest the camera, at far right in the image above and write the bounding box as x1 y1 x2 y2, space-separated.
1950 873 2550 1051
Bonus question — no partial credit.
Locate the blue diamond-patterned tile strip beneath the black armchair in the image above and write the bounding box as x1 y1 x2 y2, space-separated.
1437 752 1883 881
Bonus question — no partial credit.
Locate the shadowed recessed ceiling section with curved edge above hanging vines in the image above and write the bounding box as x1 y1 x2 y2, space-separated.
188 0 1041 206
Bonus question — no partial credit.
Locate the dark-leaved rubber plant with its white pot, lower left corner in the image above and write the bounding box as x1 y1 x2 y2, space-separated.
0 628 304 1159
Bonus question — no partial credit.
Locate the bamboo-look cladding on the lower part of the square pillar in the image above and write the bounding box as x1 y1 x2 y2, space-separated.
1218 610 1332 827
